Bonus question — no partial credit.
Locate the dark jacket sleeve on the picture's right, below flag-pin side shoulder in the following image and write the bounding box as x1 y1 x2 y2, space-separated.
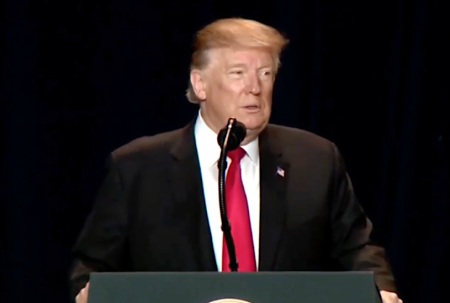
331 144 396 292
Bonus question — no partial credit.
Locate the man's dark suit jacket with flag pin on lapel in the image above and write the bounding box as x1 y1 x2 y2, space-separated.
70 119 395 295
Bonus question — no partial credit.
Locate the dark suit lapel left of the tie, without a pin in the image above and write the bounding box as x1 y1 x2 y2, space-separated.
169 122 217 271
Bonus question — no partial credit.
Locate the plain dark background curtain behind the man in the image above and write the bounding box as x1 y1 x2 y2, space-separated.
0 0 450 303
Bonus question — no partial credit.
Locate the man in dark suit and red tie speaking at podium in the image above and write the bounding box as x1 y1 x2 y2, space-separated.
71 18 402 303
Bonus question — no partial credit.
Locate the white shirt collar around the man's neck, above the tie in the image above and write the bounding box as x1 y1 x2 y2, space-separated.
194 110 259 166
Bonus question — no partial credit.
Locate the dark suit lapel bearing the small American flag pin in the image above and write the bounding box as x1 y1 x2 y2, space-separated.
259 126 289 271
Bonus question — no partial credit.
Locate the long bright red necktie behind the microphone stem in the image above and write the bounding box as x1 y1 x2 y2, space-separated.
222 147 256 271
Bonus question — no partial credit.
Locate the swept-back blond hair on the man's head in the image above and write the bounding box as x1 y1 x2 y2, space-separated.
186 18 288 104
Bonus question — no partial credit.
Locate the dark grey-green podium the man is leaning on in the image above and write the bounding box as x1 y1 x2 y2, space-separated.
88 272 381 303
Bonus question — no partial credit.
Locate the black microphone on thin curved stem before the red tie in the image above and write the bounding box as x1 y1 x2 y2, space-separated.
217 118 247 271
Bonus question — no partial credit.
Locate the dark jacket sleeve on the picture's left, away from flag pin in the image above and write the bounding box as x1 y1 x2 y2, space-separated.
69 155 128 299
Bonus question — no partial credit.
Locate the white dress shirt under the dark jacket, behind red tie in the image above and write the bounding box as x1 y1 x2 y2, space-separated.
195 112 260 271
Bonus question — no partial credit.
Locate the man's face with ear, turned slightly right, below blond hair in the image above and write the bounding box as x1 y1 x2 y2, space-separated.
191 48 275 144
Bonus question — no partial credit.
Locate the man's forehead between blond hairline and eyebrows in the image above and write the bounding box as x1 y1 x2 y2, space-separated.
209 48 274 67
